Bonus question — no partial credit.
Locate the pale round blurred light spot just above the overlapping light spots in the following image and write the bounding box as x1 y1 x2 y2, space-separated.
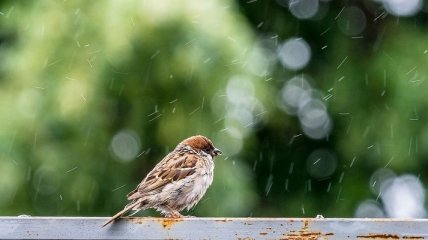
278 38 311 70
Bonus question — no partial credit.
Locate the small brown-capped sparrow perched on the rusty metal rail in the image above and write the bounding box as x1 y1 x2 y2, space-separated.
103 135 222 227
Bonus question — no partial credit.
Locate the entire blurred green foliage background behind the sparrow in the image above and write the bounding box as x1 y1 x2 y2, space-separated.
0 0 428 217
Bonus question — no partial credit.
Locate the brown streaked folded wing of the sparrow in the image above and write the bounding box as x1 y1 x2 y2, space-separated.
127 152 200 200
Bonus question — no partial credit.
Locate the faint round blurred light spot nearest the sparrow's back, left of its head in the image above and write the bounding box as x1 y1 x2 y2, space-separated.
110 129 141 162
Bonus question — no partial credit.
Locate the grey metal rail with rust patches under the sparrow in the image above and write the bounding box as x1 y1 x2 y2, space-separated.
0 217 428 240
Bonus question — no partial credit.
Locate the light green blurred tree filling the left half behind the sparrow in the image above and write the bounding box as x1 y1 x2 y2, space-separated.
0 1 266 215
